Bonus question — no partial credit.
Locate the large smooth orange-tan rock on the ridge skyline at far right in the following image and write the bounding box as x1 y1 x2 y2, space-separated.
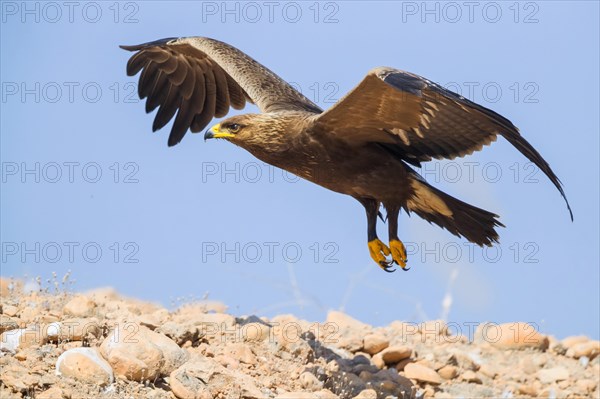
474 322 549 350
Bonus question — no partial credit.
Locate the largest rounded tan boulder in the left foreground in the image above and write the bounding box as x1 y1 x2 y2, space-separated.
100 323 189 381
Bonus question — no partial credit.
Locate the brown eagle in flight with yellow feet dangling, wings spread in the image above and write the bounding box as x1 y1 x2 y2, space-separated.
120 37 573 272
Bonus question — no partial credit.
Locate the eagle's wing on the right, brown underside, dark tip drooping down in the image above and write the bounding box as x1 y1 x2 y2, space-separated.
316 67 573 219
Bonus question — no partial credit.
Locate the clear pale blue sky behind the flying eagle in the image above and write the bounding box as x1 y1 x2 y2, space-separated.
0 1 600 338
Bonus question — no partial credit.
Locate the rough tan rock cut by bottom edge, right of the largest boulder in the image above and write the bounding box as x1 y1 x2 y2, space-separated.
169 356 264 399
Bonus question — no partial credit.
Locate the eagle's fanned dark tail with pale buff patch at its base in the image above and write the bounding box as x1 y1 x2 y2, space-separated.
406 180 504 246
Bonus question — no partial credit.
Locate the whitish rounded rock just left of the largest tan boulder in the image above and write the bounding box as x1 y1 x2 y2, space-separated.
56 348 114 386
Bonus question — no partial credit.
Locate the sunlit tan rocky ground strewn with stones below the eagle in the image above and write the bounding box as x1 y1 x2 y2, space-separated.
0 279 600 399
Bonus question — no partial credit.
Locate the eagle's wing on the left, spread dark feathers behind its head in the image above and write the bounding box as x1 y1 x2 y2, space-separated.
121 37 321 146
